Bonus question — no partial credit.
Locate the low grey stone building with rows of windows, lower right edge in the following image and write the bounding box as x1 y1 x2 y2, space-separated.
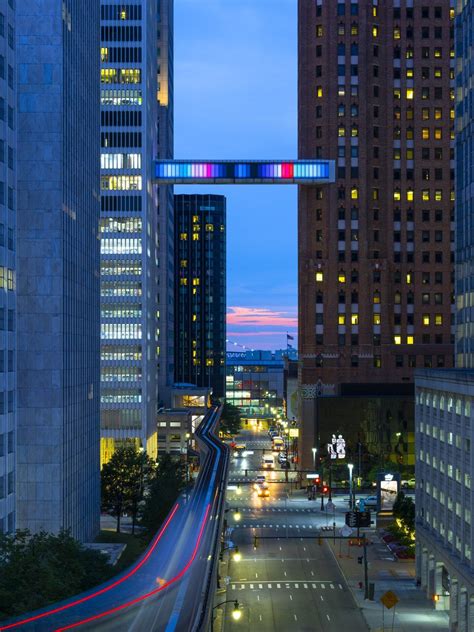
415 369 474 632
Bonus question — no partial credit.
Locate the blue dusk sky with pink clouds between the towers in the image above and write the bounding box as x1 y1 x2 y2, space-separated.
174 0 297 349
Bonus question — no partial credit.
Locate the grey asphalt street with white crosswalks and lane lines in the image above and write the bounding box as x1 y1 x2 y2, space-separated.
216 433 367 632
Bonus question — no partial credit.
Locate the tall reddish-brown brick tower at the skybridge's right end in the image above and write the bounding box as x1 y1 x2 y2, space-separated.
299 0 454 467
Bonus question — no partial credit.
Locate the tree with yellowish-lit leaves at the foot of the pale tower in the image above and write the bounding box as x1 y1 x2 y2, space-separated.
101 441 154 533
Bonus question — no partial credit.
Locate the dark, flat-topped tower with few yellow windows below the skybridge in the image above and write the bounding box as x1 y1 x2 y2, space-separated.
175 195 226 398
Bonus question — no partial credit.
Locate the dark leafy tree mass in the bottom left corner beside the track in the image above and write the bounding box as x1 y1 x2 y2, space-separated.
0 531 112 619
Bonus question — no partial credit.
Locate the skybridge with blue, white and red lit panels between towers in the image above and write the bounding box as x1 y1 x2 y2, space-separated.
155 160 334 184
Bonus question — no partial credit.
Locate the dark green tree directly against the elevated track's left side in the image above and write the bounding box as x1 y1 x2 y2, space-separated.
140 454 186 534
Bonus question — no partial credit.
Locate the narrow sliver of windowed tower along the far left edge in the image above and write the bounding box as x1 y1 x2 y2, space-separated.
0 3 17 533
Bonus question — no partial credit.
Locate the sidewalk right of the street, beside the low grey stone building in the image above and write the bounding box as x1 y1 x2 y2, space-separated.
326 529 449 632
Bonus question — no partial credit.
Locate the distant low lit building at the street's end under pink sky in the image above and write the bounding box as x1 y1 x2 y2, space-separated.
225 351 286 420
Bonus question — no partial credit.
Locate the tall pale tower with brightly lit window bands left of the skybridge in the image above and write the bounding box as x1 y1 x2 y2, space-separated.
100 0 173 462
